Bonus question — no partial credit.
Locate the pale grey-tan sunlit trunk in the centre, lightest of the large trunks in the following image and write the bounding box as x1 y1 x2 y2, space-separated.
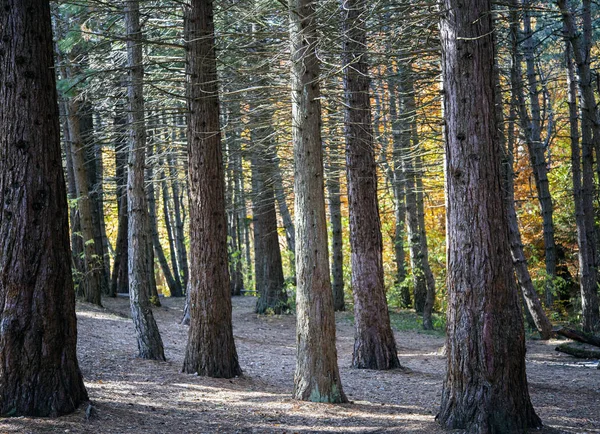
289 0 348 403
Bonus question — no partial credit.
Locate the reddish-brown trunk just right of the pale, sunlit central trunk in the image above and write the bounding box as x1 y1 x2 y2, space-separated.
341 0 400 369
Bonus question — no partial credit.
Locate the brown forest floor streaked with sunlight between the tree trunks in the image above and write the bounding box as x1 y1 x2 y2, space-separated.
0 297 600 434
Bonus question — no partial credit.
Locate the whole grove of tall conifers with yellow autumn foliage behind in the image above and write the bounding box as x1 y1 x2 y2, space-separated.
0 0 600 433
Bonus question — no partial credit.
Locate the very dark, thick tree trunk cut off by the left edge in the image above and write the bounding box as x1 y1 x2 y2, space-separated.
0 0 87 416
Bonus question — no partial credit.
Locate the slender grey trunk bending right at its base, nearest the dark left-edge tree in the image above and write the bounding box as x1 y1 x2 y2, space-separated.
125 0 165 360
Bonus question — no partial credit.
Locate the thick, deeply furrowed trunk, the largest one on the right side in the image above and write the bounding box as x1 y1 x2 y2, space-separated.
437 0 541 433
